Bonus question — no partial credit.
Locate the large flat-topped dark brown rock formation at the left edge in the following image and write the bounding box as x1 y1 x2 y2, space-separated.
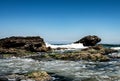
0 36 48 53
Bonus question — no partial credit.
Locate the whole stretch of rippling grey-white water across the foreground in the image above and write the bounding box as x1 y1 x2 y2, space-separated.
0 58 120 81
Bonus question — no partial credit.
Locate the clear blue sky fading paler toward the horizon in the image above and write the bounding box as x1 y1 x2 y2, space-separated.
0 0 120 44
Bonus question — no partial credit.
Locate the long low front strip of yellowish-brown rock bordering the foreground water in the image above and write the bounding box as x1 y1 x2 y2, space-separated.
30 51 110 62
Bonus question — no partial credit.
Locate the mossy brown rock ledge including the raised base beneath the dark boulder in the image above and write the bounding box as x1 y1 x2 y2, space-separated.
30 45 117 62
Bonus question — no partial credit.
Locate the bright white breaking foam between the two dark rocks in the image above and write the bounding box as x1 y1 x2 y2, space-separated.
46 43 87 49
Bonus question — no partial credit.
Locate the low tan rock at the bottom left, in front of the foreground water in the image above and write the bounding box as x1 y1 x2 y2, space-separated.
0 71 53 81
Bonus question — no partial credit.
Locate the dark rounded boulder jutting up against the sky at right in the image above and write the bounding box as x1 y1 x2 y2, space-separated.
75 35 101 46
